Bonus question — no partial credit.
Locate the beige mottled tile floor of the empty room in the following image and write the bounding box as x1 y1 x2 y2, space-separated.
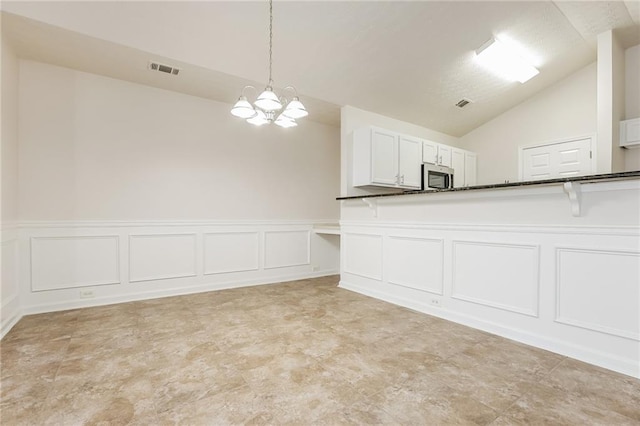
0 276 640 425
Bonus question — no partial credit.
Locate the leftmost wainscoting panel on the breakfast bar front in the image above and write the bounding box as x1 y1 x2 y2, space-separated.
342 233 382 280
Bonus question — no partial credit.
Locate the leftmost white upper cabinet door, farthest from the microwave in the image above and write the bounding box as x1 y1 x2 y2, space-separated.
371 129 398 186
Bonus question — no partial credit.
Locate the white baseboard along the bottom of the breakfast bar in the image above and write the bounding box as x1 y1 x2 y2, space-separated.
339 280 640 378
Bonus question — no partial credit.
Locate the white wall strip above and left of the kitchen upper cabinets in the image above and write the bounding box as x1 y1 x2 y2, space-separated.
340 105 458 196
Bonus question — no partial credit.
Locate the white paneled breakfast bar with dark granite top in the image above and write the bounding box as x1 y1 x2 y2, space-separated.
338 171 640 378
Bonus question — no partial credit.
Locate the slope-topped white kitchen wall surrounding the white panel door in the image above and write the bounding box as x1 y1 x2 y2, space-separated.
459 63 597 184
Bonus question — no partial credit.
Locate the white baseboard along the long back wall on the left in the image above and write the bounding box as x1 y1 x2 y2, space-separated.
21 270 339 316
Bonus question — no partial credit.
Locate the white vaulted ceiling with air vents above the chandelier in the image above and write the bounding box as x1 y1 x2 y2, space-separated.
1 0 640 136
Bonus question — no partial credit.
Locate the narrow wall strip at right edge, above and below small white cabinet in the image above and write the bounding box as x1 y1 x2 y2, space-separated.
624 44 640 170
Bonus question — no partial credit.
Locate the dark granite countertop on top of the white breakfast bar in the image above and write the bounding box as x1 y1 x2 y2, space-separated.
336 170 640 200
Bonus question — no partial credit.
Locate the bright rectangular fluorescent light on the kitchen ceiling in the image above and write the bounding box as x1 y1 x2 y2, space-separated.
476 38 540 83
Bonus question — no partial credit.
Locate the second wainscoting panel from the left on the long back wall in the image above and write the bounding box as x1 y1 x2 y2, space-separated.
129 234 196 282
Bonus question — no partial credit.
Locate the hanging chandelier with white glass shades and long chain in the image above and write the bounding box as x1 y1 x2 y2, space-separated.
231 0 309 127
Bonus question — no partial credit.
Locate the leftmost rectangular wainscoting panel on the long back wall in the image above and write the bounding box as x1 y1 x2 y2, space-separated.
31 236 120 291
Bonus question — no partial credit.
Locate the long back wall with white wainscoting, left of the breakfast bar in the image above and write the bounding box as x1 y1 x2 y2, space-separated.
2 60 340 333
